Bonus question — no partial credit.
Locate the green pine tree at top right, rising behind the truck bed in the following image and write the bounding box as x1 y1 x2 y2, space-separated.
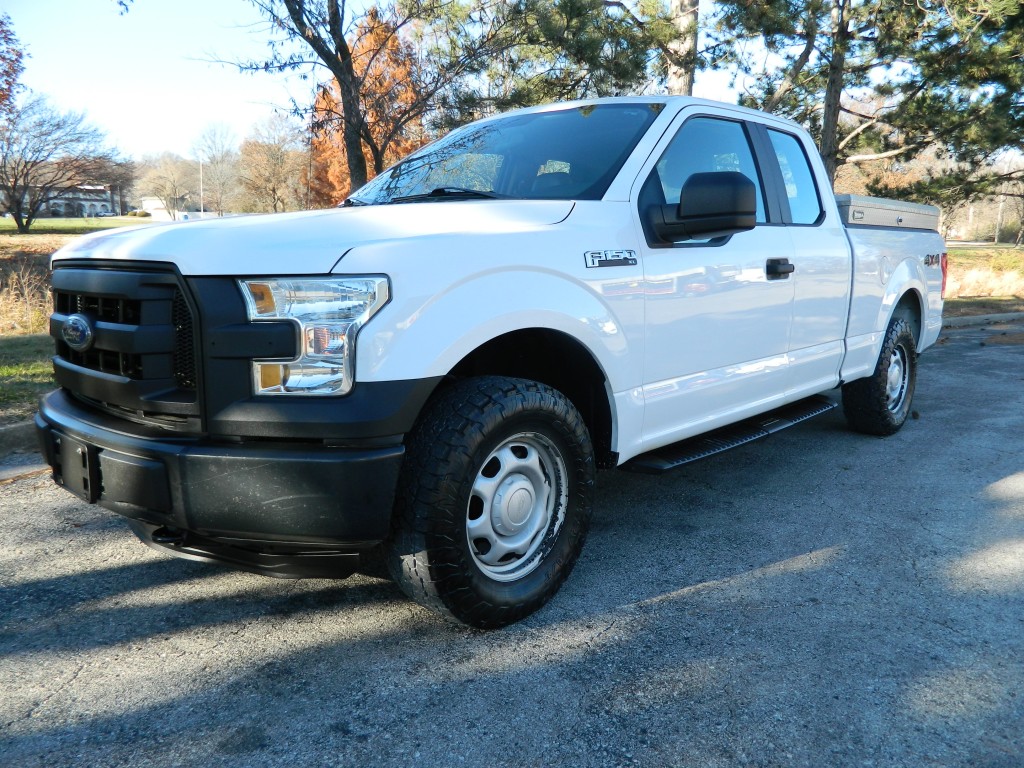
715 0 1024 186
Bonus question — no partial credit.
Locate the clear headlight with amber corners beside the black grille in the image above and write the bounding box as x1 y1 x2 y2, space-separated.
239 275 390 395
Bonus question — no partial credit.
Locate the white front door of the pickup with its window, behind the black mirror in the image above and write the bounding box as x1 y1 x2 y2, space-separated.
633 111 794 450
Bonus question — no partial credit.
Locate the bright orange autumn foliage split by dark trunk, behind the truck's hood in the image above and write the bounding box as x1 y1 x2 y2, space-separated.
309 7 427 207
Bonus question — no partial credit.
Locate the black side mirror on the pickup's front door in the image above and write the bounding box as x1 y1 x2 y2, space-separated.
647 171 758 243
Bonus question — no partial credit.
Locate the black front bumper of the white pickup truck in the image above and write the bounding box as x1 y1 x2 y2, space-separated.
36 390 404 577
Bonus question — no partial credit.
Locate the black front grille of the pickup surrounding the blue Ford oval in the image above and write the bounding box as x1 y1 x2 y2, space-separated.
50 264 199 428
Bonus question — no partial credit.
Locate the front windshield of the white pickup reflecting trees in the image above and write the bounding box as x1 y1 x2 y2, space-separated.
349 103 664 205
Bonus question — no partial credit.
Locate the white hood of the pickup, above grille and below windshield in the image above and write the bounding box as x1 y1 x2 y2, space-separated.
53 200 572 275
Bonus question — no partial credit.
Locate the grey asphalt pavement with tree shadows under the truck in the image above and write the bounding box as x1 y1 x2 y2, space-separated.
0 324 1024 768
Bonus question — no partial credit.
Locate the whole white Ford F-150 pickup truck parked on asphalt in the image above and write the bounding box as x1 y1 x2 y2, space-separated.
37 97 945 627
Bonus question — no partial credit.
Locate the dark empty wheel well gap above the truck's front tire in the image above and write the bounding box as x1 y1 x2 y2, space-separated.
450 329 617 467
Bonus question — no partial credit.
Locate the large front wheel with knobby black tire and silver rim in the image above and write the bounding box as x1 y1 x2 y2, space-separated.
389 377 594 628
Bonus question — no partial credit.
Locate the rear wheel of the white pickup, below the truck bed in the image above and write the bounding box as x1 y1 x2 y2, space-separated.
843 317 918 435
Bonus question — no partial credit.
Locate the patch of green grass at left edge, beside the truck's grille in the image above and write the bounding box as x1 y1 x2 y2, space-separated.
0 334 56 426
